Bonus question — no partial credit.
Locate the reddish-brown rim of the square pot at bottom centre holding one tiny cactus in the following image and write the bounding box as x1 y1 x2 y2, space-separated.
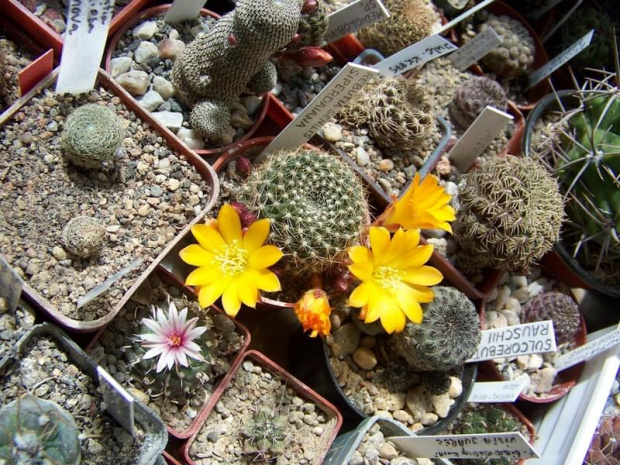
181 350 342 465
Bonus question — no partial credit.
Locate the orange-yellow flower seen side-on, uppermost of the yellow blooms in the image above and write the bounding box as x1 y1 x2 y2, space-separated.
381 173 455 233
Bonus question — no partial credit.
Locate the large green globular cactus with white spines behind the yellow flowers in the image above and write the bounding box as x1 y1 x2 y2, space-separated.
238 149 369 273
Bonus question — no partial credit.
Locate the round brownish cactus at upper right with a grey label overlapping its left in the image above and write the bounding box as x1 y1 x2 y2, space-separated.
478 14 536 78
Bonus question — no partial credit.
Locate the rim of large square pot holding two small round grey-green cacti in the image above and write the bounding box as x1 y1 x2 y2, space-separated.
0 70 219 332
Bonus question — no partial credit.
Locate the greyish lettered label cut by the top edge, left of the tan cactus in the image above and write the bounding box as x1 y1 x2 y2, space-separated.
324 0 390 44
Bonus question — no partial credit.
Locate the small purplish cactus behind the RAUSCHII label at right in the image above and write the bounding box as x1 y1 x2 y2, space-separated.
522 292 580 344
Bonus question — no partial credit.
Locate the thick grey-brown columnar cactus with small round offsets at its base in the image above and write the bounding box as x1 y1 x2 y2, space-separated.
172 0 301 143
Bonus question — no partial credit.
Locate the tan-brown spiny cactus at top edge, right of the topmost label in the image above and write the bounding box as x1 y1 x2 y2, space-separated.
357 0 439 56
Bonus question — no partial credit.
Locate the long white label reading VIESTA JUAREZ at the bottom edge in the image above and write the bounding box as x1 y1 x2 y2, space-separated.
389 433 540 463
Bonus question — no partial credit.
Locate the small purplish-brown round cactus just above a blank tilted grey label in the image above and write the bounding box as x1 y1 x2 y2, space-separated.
448 76 508 129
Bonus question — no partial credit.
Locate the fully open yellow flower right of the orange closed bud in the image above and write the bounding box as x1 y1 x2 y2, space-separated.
348 226 443 334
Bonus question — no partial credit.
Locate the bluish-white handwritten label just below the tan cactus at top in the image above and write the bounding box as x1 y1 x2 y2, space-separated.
375 34 458 77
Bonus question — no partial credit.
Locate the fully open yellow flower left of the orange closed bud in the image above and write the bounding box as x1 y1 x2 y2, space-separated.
179 204 283 317
